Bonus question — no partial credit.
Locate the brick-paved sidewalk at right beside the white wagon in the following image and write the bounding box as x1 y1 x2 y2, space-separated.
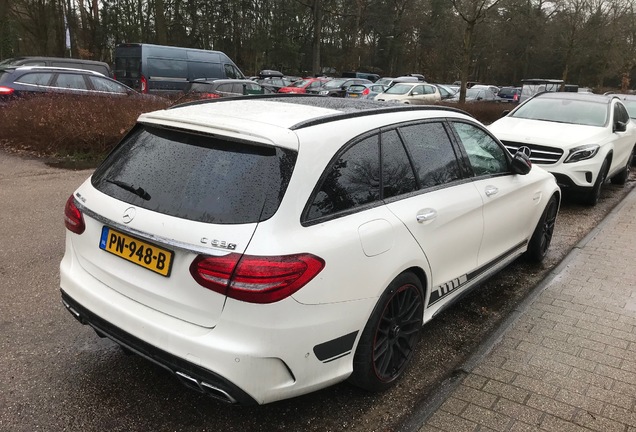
419 189 636 432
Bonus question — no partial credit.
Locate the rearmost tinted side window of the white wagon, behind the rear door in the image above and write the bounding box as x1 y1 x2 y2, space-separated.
307 135 380 220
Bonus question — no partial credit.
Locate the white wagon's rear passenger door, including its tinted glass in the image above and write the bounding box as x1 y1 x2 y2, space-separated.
382 122 483 307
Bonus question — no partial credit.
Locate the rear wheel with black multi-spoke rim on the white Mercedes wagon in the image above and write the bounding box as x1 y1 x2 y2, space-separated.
349 273 424 392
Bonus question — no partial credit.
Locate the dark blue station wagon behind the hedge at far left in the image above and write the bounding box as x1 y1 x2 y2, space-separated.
0 66 145 101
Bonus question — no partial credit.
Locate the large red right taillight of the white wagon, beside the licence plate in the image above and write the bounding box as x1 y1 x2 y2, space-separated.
190 253 325 303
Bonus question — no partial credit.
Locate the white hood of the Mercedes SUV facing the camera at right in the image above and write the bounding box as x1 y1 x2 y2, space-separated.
488 117 611 148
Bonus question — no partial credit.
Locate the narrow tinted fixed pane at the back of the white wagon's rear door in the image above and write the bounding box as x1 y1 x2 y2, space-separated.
382 130 417 198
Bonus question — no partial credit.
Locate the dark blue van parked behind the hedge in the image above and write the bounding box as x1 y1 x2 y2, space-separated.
114 43 245 94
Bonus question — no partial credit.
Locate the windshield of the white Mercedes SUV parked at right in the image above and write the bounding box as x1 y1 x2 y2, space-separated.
510 97 608 126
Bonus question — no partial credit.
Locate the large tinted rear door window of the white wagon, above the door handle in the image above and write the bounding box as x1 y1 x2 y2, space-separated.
400 123 462 188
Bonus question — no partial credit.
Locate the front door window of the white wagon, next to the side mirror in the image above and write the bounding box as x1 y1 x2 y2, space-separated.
453 123 508 176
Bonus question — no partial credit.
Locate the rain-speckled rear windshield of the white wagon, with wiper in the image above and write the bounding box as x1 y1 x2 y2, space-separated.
92 125 296 224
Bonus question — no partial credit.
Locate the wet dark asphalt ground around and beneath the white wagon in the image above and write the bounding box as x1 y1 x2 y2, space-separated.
0 152 636 432
